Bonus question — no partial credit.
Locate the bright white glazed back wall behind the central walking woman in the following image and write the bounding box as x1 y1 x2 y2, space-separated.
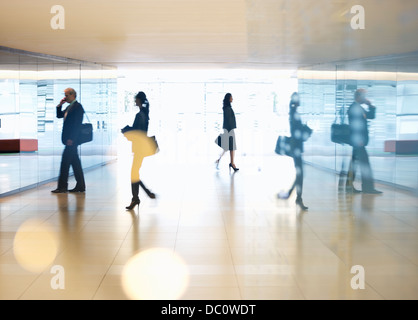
118 70 297 169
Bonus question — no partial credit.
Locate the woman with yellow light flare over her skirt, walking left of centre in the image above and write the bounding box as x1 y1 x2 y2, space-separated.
122 91 155 210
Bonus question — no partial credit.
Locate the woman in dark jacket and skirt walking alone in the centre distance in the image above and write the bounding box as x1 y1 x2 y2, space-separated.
215 93 239 172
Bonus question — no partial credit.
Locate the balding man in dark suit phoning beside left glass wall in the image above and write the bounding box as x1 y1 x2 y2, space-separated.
52 88 86 193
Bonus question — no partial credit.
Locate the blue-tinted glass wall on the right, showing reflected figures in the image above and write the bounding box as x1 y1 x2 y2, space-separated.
298 61 418 193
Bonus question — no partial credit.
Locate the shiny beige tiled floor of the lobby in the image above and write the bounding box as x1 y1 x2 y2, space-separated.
0 156 418 300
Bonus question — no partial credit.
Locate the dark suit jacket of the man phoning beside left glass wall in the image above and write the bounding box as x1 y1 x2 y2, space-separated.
57 101 84 145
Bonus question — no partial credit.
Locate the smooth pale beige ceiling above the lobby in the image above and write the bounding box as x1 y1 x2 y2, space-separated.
0 0 418 69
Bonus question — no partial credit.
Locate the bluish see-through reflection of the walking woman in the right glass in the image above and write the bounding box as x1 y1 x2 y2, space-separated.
288 92 308 210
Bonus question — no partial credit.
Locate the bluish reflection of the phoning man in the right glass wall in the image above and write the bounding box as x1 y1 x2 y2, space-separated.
346 89 382 194
